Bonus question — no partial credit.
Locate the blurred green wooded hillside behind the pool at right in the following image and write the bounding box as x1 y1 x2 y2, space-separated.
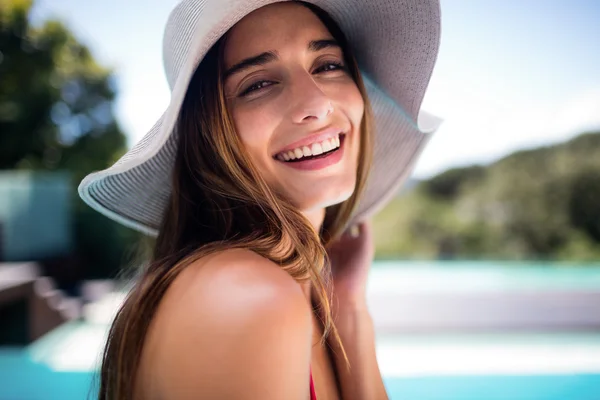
374 132 600 261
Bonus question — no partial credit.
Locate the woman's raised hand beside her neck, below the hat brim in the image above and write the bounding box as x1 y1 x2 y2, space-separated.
327 222 375 307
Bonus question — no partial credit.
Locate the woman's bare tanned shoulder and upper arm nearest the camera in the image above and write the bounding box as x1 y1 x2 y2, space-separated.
140 249 312 399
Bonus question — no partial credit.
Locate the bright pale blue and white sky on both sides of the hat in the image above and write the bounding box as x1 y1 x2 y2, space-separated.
34 0 600 178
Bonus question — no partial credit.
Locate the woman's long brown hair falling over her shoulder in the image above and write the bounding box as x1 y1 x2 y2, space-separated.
98 3 372 400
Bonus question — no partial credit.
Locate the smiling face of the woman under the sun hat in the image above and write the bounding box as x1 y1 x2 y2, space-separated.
224 2 364 216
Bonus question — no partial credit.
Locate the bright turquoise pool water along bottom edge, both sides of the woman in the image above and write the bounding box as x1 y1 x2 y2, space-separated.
0 349 600 400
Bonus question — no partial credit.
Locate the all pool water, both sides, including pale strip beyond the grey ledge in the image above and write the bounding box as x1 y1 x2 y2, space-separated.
0 262 600 400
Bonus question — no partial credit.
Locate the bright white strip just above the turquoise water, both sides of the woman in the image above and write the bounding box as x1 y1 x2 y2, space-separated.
0 322 600 377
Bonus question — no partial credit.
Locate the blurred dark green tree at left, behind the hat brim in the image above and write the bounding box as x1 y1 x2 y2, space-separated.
0 0 137 277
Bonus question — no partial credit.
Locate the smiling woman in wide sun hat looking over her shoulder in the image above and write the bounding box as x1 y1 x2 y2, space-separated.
80 0 439 400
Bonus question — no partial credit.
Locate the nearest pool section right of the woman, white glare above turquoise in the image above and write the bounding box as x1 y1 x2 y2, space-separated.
377 332 600 400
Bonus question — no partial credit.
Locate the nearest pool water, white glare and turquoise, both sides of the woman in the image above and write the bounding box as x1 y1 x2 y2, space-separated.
0 322 600 400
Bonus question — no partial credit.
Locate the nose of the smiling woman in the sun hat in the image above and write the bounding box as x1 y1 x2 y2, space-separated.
292 73 333 124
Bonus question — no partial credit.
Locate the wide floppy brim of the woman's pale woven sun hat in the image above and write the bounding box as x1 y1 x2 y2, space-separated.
79 0 441 236
